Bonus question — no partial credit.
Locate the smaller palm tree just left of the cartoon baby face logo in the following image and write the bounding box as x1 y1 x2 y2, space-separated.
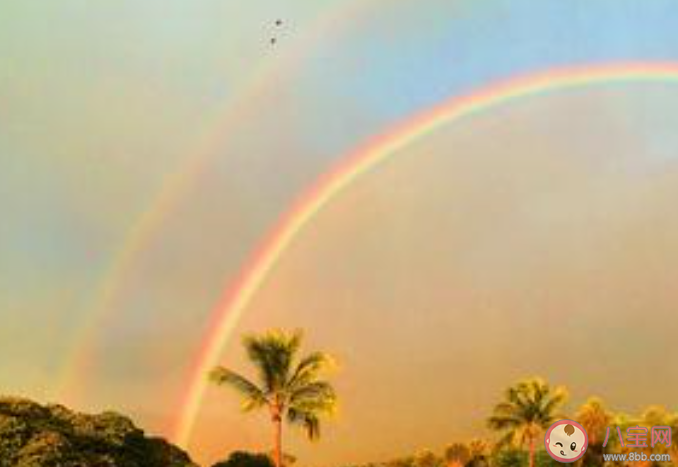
488 378 567 467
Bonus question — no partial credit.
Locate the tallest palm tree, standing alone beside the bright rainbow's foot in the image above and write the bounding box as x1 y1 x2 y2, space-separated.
209 331 337 467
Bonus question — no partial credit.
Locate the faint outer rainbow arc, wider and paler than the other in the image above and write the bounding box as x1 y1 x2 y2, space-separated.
53 0 394 401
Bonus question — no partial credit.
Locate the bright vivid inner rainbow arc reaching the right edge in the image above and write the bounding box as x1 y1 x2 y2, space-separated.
173 62 678 446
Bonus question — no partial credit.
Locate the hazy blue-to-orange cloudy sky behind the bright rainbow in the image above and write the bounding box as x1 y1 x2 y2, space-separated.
0 0 678 466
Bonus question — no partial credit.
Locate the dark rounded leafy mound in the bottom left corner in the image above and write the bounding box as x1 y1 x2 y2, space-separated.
0 397 197 467
